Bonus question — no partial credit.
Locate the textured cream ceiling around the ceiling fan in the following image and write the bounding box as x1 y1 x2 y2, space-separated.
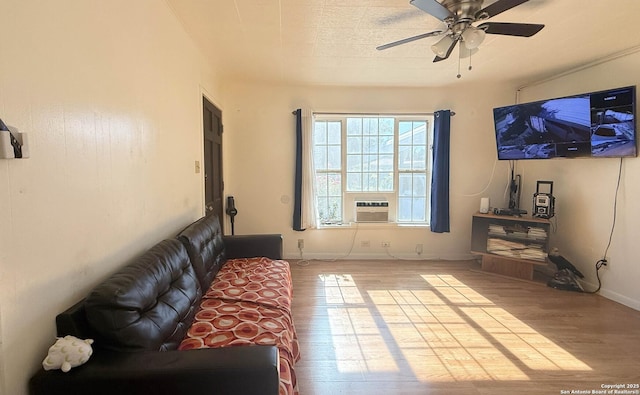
167 0 640 87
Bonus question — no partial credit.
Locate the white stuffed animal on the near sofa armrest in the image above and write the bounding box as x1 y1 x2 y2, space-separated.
42 336 93 373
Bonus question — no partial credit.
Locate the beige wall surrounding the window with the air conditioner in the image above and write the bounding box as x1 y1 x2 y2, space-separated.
224 83 513 259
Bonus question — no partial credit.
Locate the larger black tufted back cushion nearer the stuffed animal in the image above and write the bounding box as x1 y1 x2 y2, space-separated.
84 239 202 351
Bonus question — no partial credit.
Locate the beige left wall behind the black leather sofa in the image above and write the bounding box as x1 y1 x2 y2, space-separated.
0 0 221 395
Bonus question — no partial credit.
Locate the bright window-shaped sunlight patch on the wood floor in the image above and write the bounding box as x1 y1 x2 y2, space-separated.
320 274 591 381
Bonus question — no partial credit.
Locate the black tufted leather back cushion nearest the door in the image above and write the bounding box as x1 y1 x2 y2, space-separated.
178 215 226 290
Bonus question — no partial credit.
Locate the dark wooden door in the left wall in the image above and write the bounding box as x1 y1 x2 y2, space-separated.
202 97 224 225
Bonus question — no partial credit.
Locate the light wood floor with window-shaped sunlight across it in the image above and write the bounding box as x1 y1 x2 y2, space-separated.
291 261 640 395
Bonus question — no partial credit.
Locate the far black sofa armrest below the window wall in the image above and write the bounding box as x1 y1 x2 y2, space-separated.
222 234 282 259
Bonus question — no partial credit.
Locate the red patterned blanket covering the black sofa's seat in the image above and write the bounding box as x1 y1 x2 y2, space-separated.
179 258 300 395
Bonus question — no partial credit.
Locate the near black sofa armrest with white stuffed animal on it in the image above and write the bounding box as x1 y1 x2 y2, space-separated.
29 346 279 395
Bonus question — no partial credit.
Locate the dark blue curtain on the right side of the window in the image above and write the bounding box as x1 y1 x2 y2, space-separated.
430 110 451 233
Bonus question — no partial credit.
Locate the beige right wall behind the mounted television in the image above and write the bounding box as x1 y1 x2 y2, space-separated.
518 52 640 310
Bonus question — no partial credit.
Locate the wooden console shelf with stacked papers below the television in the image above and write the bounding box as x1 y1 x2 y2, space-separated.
471 213 551 280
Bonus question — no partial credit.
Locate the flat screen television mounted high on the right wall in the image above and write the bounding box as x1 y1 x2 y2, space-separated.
493 86 637 160
